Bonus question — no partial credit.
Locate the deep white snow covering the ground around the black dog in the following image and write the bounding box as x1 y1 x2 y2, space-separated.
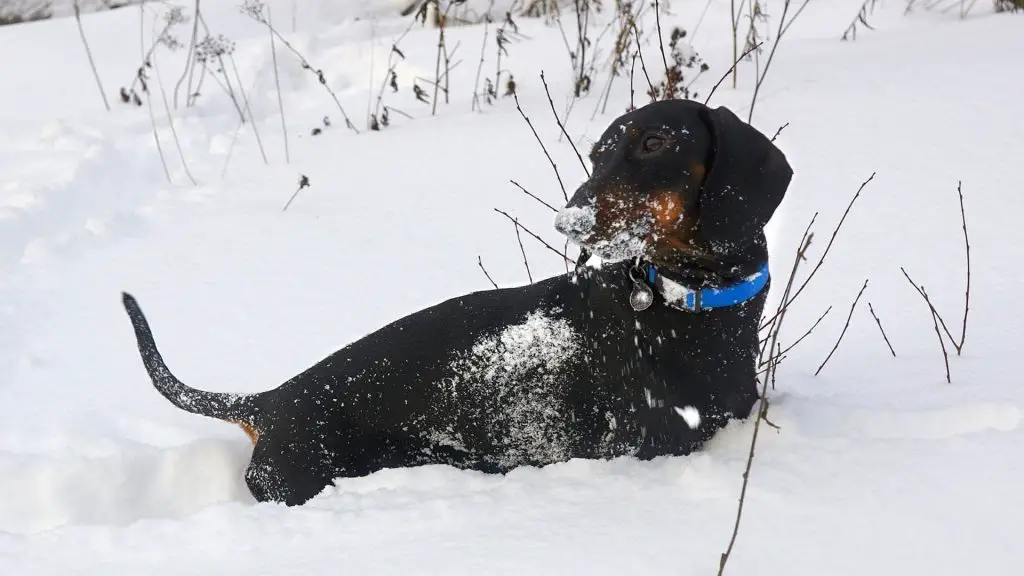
0 0 1024 576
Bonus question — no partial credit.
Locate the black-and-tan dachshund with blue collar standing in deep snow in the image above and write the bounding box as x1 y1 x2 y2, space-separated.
124 100 793 505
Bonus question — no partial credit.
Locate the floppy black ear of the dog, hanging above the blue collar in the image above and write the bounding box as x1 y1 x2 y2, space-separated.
694 108 793 254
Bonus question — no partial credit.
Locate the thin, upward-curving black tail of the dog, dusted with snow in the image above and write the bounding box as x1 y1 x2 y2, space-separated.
121 292 259 444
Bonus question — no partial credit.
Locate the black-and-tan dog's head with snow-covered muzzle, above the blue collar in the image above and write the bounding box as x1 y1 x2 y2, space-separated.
555 100 793 261
